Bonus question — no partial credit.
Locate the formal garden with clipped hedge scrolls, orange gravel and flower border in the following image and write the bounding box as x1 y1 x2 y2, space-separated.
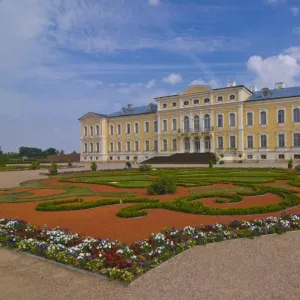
0 165 300 283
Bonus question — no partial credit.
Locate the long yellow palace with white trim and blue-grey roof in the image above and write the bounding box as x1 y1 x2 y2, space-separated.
79 82 300 162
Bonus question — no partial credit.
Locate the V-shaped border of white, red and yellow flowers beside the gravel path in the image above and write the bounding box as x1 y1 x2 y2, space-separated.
0 213 300 283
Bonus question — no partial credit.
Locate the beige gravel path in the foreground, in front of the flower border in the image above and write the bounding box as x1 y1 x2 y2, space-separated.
0 231 300 300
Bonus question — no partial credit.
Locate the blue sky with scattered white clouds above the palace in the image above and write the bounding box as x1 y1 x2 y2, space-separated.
0 0 300 152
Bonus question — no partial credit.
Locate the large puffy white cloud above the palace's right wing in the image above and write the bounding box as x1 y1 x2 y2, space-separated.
247 48 300 88
